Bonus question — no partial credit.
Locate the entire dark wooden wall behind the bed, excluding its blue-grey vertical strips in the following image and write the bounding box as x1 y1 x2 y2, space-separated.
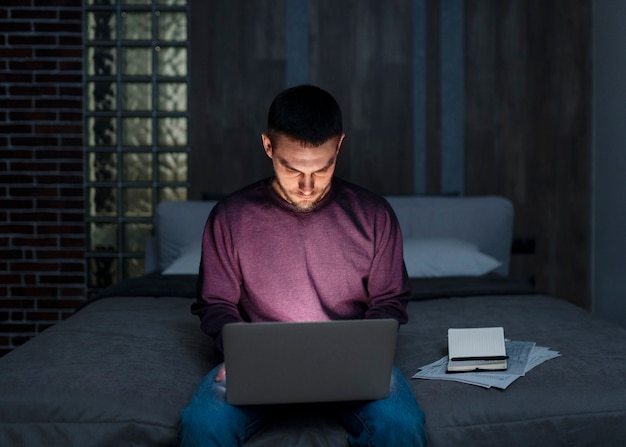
191 0 591 308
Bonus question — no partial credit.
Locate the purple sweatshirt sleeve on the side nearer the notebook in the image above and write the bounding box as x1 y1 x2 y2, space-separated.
365 205 411 324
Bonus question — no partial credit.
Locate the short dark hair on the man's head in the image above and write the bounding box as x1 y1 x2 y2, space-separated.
267 85 343 146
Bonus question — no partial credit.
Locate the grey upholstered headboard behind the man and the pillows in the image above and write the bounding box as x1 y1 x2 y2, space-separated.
146 196 513 275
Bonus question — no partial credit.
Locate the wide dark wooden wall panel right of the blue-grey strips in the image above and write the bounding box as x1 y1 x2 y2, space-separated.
465 0 591 308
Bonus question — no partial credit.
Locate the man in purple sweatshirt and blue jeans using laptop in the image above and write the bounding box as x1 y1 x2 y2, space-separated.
181 85 425 447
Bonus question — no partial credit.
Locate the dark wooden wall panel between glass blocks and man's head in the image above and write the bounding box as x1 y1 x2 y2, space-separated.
190 0 286 199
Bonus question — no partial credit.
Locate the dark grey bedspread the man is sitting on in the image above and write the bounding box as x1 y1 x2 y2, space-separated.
0 280 626 447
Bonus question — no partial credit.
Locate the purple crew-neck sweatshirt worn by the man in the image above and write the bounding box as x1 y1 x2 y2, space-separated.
192 178 410 350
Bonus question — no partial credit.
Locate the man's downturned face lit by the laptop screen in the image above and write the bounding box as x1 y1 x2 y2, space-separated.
261 134 345 211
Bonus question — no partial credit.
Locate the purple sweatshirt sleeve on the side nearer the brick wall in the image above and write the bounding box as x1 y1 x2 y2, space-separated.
191 204 243 352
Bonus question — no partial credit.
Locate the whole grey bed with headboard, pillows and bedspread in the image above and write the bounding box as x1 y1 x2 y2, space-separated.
0 196 626 447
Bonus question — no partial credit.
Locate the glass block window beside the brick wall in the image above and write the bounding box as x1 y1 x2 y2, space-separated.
84 0 189 294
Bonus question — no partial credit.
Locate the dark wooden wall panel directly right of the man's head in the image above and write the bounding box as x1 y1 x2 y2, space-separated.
310 0 413 194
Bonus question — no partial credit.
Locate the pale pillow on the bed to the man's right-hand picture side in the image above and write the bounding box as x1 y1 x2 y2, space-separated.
403 238 502 278
